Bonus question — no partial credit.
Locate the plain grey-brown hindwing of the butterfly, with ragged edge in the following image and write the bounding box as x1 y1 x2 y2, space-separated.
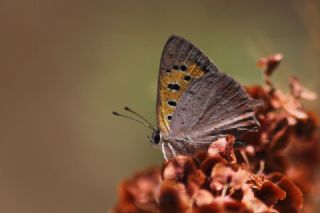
170 72 261 142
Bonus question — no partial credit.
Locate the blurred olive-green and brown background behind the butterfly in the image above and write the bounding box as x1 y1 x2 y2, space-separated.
0 0 320 213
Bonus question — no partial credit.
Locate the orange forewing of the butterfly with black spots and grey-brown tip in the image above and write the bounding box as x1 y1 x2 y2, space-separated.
157 35 217 136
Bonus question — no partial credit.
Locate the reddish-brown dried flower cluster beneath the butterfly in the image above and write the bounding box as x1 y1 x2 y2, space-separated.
112 54 318 213
